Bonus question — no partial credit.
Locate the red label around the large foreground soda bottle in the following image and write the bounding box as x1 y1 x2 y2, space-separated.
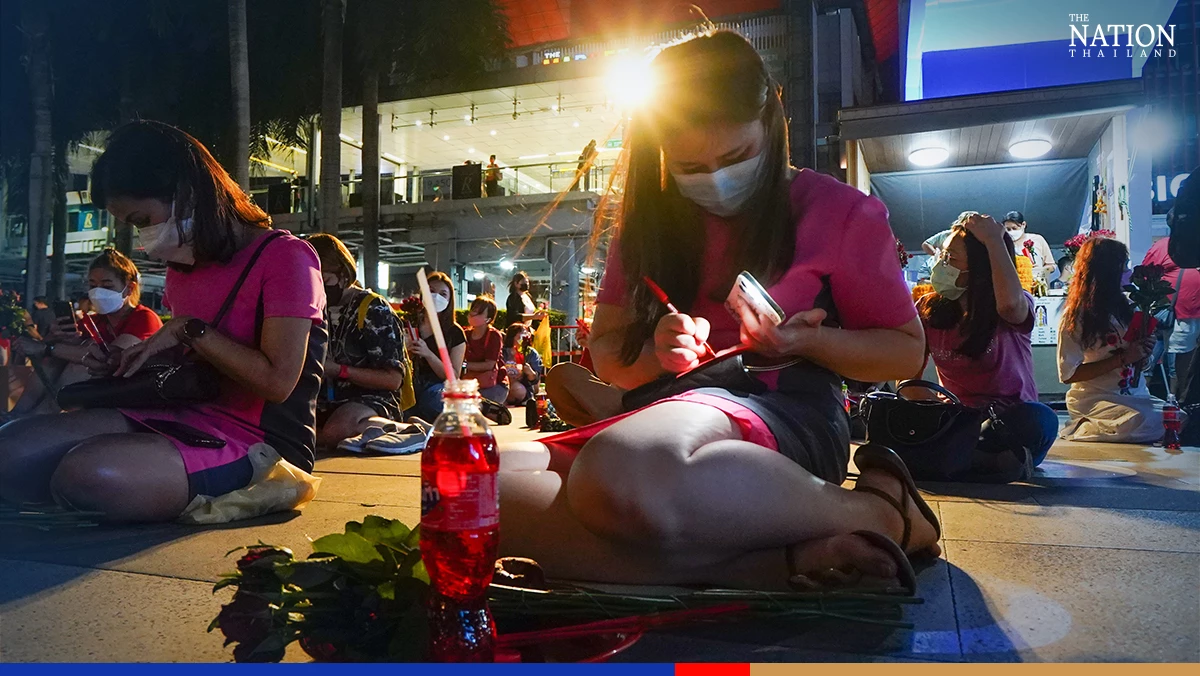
421 471 500 531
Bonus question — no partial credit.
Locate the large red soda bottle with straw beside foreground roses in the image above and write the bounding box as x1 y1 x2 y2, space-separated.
421 379 500 662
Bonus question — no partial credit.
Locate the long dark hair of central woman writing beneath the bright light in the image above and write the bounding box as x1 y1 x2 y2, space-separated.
609 31 797 364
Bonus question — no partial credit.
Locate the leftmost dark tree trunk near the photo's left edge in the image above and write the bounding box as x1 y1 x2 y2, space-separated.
22 2 54 307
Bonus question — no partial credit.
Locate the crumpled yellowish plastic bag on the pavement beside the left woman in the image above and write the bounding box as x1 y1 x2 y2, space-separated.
178 443 320 524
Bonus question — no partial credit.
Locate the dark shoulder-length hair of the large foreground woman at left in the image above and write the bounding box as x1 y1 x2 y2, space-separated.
91 120 271 269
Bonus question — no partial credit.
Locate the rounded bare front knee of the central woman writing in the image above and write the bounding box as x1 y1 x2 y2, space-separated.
566 432 683 545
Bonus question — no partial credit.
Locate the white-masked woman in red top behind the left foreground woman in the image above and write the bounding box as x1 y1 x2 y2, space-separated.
12 249 162 417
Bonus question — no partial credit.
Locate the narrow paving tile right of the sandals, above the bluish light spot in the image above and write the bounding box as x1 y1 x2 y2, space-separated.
941 502 1200 552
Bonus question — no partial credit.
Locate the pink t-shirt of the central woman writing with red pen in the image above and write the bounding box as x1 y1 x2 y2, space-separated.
596 169 917 349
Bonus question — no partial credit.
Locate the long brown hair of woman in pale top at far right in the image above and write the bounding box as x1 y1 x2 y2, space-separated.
1062 238 1133 348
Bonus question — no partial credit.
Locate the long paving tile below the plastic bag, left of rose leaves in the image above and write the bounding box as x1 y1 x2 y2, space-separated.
0 502 420 581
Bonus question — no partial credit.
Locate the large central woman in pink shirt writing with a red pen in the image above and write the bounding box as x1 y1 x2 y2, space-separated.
500 31 938 588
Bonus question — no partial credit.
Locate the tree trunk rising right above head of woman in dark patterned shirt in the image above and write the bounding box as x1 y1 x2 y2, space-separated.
320 0 346 235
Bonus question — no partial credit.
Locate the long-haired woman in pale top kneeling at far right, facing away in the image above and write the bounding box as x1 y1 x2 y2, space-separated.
1058 238 1163 443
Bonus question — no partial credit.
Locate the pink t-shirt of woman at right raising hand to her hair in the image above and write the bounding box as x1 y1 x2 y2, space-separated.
925 293 1038 408
